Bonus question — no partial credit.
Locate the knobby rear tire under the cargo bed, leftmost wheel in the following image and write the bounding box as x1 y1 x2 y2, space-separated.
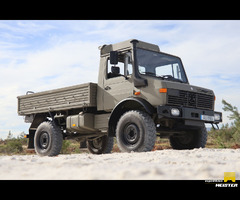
34 121 63 156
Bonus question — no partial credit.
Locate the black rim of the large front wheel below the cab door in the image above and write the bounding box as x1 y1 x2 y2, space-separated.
123 124 140 145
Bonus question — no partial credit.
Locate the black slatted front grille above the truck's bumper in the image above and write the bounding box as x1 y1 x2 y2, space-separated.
168 90 214 110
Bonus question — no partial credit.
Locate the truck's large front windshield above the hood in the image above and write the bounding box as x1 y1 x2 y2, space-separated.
137 49 187 83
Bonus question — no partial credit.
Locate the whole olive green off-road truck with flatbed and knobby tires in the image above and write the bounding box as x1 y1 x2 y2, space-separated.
17 39 222 156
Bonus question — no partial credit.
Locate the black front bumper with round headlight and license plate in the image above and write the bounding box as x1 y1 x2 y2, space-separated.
157 105 222 124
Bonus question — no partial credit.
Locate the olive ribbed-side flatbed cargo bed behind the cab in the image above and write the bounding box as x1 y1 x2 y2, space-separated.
17 83 97 116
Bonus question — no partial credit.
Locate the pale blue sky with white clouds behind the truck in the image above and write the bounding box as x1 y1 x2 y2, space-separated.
0 20 240 139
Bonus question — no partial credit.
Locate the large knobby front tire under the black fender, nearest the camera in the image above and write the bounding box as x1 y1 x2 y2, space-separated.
116 110 156 152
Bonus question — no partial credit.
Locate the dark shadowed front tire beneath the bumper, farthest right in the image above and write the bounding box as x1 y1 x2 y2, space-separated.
169 126 207 150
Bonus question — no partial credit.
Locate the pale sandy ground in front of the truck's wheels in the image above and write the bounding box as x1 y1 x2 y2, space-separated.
0 148 240 180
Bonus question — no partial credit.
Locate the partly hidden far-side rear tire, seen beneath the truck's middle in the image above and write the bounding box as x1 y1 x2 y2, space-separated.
87 135 114 154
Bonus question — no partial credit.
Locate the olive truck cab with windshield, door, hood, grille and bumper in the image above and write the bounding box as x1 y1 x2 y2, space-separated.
98 39 222 139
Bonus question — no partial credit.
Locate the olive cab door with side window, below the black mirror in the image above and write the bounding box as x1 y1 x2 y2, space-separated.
103 52 134 111
